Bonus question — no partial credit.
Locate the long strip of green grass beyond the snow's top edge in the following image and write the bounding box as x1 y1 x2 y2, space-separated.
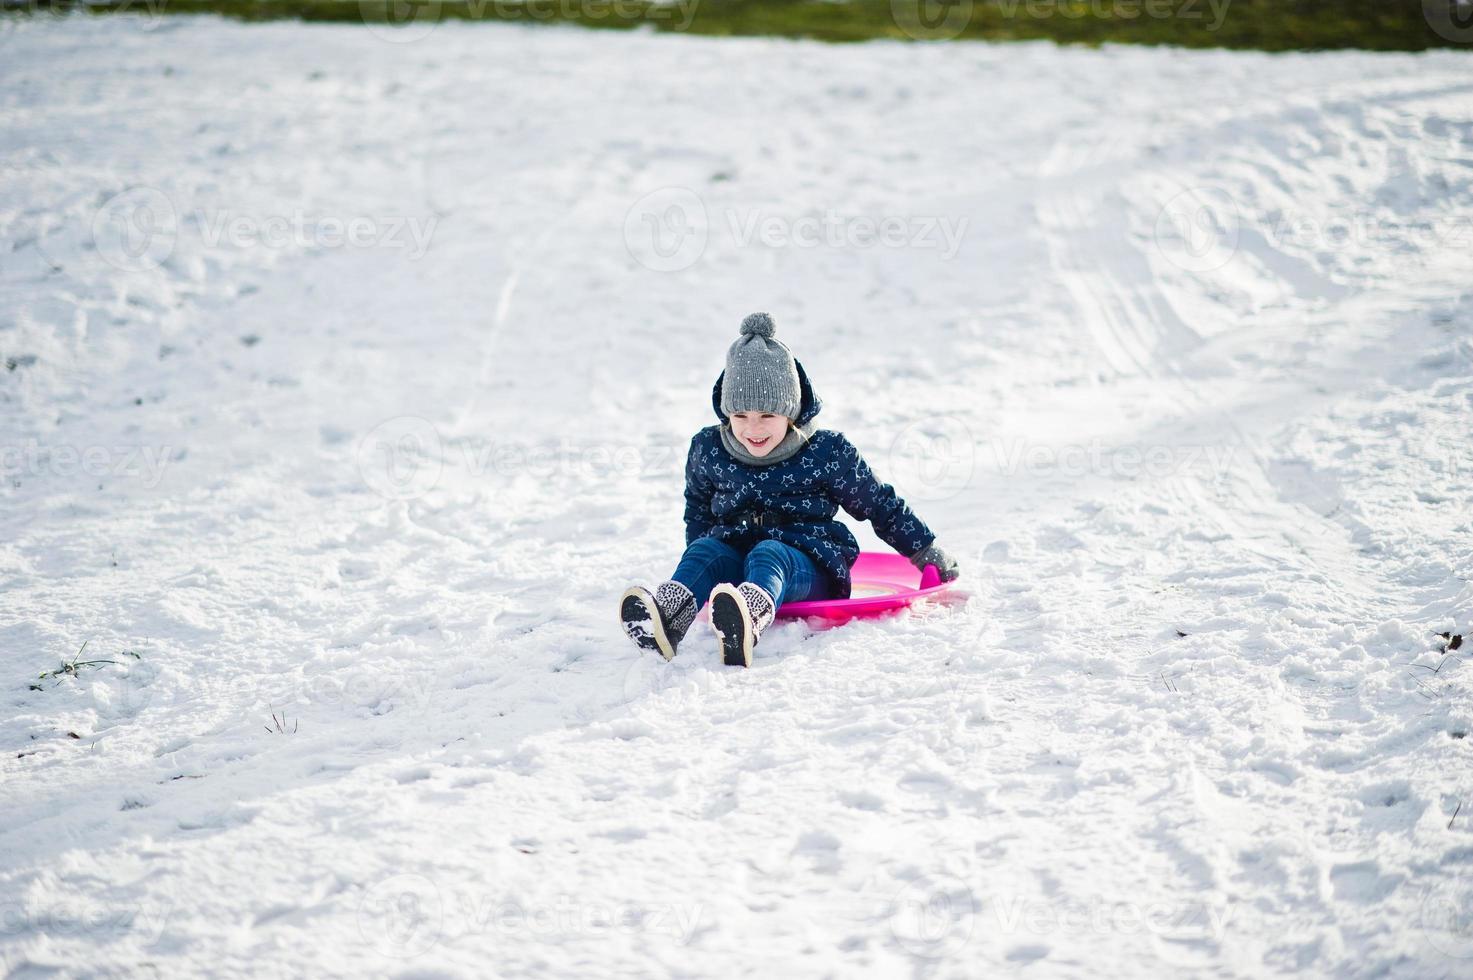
11 0 1473 52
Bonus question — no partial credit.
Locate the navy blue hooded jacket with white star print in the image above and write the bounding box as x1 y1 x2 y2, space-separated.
685 364 935 598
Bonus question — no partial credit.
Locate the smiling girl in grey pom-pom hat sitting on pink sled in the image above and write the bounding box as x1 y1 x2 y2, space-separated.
619 312 959 666
